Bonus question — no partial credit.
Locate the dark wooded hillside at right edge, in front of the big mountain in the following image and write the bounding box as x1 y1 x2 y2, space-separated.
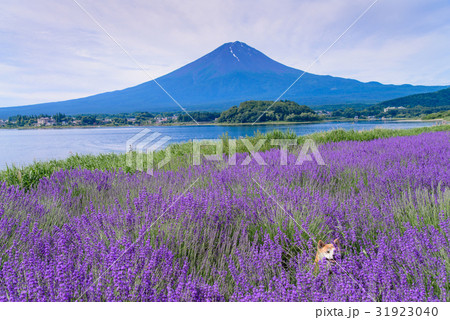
379 88 450 108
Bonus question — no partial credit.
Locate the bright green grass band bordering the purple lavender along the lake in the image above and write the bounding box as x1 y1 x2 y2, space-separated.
0 125 450 189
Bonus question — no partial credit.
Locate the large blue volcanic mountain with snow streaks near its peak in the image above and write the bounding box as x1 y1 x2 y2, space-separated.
0 41 444 118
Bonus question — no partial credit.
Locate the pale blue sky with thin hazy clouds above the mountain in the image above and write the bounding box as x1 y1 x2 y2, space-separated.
0 0 450 107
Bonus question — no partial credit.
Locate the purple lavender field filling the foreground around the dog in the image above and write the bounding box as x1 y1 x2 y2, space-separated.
0 131 450 301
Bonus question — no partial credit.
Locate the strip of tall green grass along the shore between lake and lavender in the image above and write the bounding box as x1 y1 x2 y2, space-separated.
0 125 450 188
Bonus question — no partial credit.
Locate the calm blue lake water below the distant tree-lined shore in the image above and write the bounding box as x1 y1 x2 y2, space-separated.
0 121 433 170
